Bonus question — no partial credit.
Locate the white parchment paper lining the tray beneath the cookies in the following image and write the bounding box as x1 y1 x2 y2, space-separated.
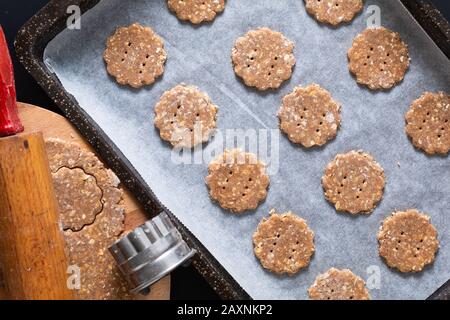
45 0 450 299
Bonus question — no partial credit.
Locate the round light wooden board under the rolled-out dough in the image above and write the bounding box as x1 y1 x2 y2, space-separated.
0 103 170 300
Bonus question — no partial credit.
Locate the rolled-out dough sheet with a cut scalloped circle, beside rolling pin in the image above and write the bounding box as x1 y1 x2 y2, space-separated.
46 139 132 300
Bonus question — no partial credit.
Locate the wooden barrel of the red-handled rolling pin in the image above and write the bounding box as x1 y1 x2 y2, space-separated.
0 133 73 300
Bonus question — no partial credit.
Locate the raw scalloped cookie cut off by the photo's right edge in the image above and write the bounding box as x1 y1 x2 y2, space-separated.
406 92 450 155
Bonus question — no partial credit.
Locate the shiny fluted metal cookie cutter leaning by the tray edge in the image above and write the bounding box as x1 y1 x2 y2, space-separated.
109 212 196 294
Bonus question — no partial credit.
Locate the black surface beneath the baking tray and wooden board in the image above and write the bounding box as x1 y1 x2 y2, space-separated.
0 0 450 299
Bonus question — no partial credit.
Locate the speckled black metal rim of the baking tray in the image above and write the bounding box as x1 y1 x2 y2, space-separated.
15 0 450 300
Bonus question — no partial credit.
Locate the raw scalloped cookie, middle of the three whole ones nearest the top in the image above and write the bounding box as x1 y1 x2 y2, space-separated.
231 28 296 91
